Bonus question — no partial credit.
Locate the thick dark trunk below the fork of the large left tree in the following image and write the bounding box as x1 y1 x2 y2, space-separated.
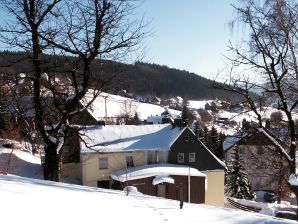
43 144 61 182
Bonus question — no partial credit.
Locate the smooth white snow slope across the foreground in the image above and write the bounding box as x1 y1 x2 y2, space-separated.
0 175 296 224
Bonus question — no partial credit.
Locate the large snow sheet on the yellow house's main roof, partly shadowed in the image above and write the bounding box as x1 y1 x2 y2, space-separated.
81 124 184 153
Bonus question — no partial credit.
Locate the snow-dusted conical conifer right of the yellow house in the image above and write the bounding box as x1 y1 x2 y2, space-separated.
225 146 254 200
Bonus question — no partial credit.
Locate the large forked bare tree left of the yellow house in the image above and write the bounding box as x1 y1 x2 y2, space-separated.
1 0 145 181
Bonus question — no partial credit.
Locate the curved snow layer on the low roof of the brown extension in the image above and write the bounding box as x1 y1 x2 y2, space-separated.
111 163 206 182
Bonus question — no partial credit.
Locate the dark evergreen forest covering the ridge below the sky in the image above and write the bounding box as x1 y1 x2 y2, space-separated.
0 51 239 100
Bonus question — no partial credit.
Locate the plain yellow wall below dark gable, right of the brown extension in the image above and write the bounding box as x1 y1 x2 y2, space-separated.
202 170 225 207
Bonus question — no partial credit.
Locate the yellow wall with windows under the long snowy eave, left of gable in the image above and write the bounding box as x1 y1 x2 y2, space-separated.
81 152 147 187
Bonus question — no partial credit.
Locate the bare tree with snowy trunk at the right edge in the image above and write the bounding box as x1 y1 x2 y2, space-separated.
218 0 298 214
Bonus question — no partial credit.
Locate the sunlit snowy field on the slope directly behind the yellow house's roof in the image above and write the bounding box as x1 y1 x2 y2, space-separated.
81 90 181 120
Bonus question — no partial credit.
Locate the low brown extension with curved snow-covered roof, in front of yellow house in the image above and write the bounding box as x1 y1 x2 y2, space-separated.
111 163 207 203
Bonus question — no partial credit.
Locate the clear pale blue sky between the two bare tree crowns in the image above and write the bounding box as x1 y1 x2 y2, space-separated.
138 0 237 78
